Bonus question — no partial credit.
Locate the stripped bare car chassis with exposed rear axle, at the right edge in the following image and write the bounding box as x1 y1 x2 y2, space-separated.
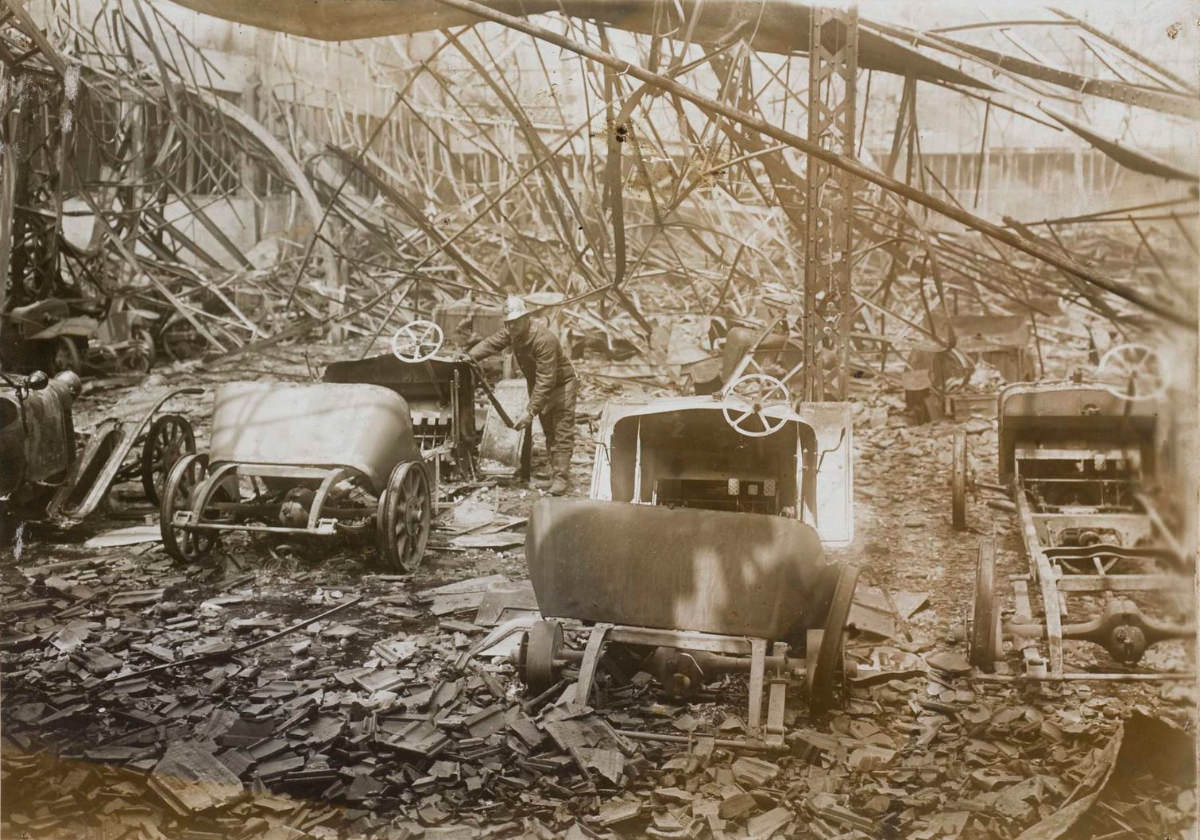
952 344 1195 679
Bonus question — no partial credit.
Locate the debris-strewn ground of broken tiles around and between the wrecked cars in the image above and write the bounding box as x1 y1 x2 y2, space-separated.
0 348 1195 840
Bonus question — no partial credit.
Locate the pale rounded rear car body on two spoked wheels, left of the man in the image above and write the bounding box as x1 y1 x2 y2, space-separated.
160 382 434 570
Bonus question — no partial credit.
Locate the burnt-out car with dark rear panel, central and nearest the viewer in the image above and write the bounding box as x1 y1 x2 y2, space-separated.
520 397 858 745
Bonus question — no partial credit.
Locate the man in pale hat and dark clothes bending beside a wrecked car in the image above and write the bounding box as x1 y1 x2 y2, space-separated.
470 296 578 496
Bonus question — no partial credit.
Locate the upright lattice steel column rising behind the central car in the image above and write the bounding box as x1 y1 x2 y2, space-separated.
803 7 858 401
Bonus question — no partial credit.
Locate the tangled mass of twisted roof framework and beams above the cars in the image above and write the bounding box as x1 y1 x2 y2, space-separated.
4 0 1200 391
